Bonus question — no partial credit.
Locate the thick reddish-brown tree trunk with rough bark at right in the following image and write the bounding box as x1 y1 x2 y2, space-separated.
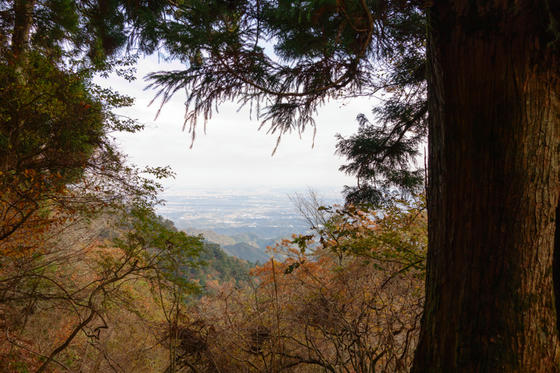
413 0 560 373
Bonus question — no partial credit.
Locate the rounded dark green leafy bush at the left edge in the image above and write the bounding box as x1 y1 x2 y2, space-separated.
0 53 105 184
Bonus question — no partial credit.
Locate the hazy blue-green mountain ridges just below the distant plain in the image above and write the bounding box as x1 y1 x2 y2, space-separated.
184 228 281 263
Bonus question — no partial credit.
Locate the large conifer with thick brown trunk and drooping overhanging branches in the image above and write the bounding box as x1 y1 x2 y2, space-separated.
142 0 560 372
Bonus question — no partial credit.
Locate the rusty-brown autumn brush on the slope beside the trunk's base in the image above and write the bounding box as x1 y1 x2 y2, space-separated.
173 196 427 372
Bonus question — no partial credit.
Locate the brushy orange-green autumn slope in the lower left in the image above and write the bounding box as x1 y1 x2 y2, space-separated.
0 211 249 372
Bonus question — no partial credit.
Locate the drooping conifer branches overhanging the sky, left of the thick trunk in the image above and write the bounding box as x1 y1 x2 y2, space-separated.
143 0 427 202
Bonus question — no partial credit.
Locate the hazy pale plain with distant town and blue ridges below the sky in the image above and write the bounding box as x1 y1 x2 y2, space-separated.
158 188 342 263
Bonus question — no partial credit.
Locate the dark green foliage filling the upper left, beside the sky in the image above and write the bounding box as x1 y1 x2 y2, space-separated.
0 0 175 250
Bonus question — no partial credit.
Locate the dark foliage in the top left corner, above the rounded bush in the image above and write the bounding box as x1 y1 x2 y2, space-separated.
0 0 168 68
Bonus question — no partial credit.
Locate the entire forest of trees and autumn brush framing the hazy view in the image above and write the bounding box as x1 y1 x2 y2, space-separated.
0 0 560 373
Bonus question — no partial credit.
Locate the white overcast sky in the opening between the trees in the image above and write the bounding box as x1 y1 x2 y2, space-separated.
103 56 372 194
